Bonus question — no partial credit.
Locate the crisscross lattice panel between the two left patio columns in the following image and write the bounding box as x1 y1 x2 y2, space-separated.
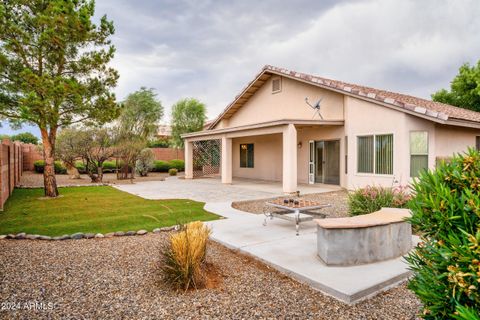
193 140 221 178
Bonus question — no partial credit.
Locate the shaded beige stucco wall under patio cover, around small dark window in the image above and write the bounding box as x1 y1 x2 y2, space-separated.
232 134 283 181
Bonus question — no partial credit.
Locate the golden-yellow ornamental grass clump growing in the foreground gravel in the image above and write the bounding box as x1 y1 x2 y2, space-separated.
162 221 211 290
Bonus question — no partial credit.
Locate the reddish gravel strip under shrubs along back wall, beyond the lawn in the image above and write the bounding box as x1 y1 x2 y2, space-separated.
19 171 178 187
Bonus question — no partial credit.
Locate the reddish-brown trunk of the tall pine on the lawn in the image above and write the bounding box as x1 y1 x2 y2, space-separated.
40 128 58 198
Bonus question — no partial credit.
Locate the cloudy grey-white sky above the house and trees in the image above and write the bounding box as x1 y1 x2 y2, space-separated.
0 0 480 138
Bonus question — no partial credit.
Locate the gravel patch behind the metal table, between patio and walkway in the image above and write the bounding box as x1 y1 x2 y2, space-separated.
232 190 348 218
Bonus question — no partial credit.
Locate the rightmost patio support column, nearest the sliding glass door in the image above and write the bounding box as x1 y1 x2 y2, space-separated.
283 124 297 193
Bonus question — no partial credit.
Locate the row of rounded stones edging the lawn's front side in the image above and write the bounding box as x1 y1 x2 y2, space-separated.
0 225 180 241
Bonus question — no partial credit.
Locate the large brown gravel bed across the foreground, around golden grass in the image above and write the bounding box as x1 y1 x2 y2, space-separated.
0 234 420 319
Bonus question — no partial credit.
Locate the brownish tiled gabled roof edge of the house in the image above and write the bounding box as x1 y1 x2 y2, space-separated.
209 65 480 129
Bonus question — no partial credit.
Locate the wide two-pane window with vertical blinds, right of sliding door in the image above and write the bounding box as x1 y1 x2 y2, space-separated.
357 134 393 174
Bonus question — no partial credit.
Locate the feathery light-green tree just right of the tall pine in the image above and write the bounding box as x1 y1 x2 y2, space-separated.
115 87 163 179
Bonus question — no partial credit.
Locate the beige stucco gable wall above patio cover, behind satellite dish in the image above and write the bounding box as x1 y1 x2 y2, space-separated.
223 78 343 129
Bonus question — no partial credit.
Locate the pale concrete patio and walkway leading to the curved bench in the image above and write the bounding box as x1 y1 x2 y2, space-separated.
116 179 410 303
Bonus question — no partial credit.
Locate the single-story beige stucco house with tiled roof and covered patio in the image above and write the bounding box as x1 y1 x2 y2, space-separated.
183 65 480 193
